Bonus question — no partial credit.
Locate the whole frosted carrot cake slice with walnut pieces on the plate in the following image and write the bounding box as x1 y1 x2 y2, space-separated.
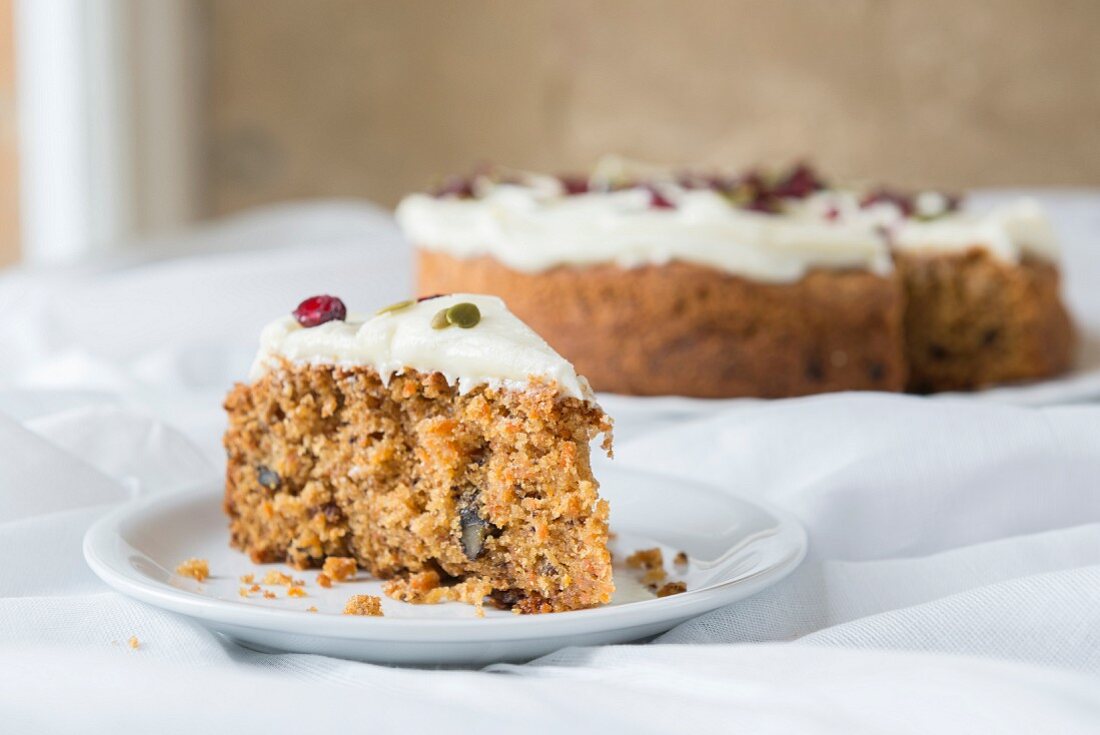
224 294 614 613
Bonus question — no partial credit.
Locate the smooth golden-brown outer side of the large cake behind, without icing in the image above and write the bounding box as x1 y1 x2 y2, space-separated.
418 250 906 397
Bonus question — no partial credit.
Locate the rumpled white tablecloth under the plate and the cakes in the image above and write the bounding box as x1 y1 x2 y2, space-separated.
0 193 1100 734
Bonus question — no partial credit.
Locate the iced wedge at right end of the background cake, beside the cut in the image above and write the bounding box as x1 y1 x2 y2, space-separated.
889 194 1075 393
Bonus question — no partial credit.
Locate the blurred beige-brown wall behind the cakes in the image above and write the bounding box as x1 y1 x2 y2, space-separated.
0 0 1100 264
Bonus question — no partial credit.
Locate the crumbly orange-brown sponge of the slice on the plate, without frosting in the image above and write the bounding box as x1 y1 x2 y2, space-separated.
224 361 614 612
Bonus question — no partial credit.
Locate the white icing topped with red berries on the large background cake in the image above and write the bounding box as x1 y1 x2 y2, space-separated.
397 161 1057 282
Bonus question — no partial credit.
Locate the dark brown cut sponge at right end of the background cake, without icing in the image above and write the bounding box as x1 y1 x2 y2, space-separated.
895 248 1075 393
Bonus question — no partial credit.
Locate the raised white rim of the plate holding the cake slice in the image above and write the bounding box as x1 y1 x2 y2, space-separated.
81 467 809 643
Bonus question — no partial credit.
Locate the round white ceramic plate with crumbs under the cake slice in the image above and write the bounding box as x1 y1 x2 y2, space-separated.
84 468 806 666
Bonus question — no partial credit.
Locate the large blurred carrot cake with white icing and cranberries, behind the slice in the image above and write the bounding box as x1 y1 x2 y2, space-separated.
397 160 1074 397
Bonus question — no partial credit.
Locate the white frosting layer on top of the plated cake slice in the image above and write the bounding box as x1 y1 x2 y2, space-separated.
251 294 593 401
